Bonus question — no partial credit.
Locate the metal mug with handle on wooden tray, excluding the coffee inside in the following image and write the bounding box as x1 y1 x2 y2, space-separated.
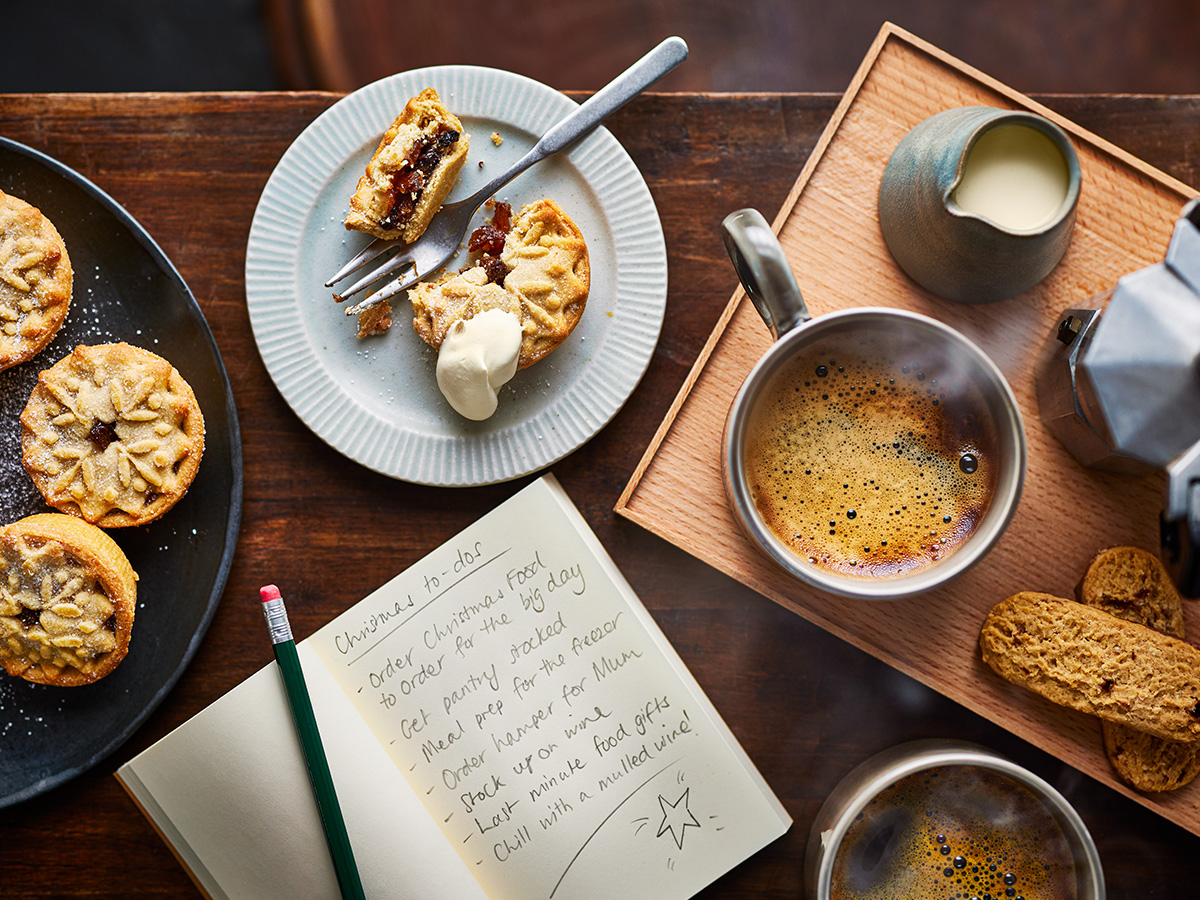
721 209 1026 600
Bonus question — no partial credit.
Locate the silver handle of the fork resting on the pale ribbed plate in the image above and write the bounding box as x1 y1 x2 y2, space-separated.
464 37 688 206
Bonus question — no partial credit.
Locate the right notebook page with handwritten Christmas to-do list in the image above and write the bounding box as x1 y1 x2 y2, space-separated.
310 479 788 900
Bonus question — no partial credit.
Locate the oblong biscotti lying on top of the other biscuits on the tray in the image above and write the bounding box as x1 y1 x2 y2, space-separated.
979 592 1200 740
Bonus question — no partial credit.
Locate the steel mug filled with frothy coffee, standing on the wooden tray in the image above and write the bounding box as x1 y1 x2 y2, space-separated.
722 210 1026 600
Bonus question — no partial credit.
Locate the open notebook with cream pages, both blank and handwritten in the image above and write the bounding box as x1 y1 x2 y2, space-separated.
116 476 791 900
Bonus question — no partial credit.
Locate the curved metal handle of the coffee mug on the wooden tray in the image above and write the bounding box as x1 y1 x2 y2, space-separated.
721 209 812 340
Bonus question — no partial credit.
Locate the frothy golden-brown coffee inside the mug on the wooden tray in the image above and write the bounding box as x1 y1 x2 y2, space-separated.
745 335 1000 577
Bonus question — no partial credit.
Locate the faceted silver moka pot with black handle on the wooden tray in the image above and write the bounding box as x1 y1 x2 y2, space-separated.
1037 198 1200 598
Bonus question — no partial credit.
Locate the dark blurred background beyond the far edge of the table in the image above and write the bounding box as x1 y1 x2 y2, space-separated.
7 0 1200 95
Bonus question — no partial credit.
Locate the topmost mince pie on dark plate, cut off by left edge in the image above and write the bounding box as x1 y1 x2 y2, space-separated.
0 191 72 370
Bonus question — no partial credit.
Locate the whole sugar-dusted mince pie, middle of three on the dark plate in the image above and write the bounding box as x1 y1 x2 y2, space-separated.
20 343 204 528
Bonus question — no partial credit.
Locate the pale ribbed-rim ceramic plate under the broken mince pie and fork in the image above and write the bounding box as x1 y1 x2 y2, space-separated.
246 66 667 486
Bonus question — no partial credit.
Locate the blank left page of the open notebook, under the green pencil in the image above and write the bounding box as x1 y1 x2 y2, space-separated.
118 632 486 900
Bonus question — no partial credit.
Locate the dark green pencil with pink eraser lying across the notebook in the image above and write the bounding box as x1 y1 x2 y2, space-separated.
258 584 366 900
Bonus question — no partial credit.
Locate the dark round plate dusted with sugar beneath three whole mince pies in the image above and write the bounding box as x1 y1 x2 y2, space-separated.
0 138 242 806
